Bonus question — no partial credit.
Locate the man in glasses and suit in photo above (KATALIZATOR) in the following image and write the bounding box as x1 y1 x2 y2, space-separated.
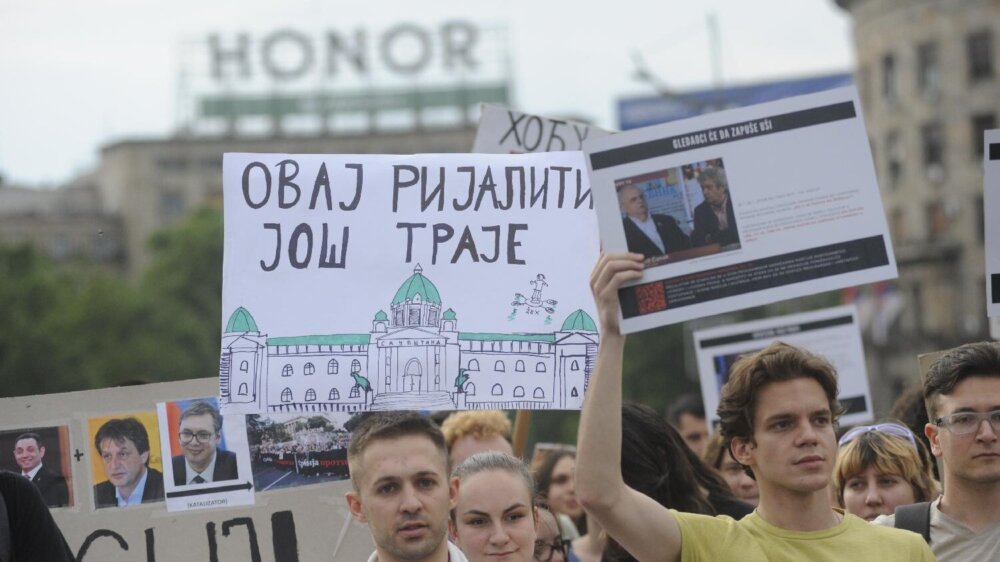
171 401 239 486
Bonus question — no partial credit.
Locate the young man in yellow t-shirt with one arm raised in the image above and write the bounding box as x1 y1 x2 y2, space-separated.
576 254 934 562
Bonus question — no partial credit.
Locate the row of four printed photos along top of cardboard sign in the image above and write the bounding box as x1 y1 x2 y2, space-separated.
0 397 360 511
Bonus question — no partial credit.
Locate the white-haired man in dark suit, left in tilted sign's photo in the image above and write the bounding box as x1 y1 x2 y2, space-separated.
618 185 691 259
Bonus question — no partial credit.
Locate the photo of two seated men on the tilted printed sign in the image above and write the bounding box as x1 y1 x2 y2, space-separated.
615 158 740 267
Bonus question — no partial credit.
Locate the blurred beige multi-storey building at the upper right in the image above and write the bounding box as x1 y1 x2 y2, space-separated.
837 0 1000 402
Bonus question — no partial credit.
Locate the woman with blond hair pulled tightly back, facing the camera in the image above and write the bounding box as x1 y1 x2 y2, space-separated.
449 451 538 562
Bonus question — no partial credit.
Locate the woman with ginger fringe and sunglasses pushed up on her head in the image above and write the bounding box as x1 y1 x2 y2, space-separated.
833 423 938 521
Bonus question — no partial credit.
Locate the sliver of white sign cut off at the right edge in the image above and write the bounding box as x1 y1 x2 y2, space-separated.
983 129 1000 318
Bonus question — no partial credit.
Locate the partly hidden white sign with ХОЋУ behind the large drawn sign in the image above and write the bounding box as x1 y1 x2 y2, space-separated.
472 104 611 154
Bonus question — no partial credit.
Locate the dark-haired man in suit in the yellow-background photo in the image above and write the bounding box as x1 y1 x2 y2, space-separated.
94 417 163 509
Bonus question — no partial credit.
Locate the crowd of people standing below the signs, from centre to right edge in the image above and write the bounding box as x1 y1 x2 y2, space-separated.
347 250 1000 562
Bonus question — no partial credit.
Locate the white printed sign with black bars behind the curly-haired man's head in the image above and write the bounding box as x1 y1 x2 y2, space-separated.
693 305 873 425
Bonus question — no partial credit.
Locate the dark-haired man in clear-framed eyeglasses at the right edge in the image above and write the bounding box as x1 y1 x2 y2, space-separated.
875 342 1000 562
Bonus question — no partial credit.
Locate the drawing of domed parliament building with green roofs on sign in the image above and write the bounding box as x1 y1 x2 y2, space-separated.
219 264 598 412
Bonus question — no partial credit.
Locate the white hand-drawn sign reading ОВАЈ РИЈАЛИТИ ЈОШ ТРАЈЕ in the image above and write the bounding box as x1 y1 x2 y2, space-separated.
219 152 599 414
